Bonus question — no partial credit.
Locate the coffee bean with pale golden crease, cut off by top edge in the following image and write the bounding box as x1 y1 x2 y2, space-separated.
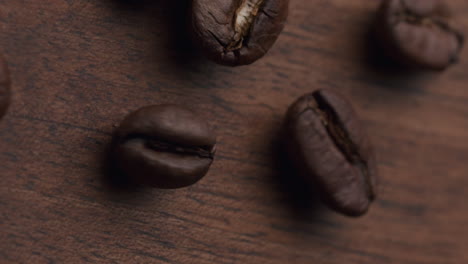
192 0 289 66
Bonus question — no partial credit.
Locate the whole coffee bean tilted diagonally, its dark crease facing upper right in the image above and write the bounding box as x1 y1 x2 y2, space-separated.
285 90 377 216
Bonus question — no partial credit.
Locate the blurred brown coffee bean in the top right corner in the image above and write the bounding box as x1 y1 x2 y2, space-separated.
376 0 464 70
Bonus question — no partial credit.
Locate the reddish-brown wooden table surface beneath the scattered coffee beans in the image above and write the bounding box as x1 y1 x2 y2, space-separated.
0 0 468 264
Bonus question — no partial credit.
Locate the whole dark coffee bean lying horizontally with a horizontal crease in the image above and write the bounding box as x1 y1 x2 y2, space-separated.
113 105 216 189
